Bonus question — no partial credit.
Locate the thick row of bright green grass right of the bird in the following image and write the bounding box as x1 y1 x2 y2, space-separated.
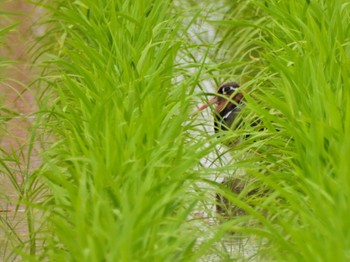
211 1 350 261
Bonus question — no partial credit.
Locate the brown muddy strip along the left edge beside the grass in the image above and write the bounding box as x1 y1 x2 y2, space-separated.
0 0 43 260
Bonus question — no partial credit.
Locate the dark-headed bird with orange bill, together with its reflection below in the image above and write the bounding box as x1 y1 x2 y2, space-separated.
197 82 255 217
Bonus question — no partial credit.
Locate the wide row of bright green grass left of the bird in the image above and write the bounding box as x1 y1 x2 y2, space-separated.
32 1 213 261
